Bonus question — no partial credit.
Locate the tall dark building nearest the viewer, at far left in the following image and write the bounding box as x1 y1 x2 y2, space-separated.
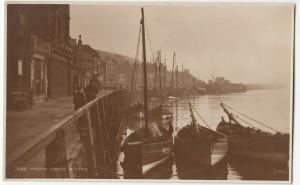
7 4 73 106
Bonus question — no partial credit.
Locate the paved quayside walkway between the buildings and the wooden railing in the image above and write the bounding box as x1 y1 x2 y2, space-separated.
6 90 110 155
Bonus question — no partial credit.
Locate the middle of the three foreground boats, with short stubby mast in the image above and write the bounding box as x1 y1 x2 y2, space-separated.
174 103 227 167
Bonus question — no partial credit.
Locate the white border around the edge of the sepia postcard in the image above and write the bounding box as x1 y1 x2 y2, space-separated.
0 0 300 185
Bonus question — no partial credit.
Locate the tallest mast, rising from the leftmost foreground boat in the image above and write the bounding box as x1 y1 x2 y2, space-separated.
141 8 149 133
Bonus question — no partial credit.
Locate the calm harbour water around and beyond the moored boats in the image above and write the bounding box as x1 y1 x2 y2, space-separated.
119 89 291 180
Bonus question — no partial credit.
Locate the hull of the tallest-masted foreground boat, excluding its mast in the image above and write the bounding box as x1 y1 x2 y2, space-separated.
123 123 173 176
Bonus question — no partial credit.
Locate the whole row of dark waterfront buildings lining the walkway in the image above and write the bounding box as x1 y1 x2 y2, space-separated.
7 4 117 107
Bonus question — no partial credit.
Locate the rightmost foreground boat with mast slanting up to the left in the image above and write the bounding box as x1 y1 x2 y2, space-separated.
217 103 289 165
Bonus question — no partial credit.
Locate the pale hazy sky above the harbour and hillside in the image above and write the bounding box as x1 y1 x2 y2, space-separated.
71 4 294 84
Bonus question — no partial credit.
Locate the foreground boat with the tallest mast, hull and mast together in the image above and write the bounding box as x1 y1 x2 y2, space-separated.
122 8 173 176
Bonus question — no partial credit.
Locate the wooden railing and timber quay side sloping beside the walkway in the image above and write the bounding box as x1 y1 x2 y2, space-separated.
6 91 127 178
